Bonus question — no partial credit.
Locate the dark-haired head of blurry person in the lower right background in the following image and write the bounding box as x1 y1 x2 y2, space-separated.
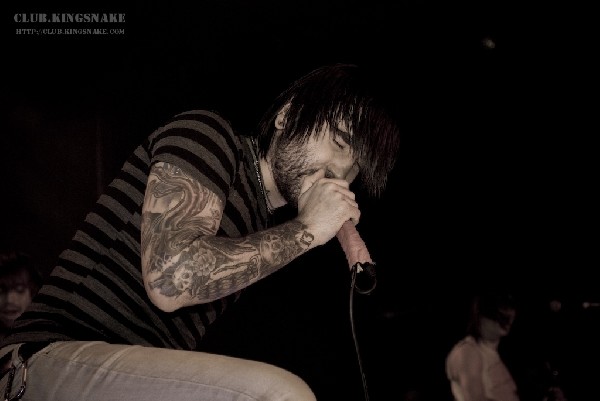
467 291 517 342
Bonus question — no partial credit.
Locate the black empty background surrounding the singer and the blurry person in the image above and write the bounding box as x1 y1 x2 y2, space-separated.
0 0 600 401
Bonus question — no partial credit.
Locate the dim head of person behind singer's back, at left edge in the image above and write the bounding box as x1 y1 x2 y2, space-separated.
0 252 42 334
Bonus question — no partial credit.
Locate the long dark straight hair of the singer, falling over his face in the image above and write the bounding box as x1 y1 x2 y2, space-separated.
257 64 400 197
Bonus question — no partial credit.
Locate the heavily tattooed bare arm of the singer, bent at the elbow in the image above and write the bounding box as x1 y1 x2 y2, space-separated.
141 163 314 312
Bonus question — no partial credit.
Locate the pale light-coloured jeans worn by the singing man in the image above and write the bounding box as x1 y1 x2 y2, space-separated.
0 341 316 401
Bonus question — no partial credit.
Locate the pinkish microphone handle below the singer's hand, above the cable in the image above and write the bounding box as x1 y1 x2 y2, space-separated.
336 221 377 294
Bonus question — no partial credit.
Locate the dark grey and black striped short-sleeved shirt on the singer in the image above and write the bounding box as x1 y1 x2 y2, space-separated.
0 110 268 350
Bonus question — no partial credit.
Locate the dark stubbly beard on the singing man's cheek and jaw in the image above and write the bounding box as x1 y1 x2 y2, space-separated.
271 141 316 209
